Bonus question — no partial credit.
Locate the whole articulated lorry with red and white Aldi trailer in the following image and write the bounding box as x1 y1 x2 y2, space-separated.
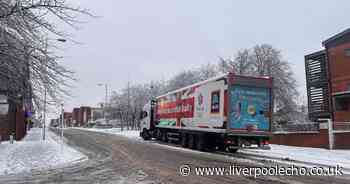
140 73 273 152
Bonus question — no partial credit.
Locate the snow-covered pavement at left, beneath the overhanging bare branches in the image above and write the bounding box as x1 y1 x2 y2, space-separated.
0 128 87 175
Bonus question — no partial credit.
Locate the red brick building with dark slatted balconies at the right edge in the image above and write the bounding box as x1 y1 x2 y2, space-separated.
305 29 350 122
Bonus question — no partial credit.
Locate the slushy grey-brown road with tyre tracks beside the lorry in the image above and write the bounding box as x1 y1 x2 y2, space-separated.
0 129 350 184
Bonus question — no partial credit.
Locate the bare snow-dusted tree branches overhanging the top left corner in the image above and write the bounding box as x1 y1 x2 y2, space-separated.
0 0 91 108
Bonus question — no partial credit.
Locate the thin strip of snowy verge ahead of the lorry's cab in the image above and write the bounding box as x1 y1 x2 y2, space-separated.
75 127 141 139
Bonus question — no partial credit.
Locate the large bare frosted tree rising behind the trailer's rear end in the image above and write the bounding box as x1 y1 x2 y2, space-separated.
218 44 298 123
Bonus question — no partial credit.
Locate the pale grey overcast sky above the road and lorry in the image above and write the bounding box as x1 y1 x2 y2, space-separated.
58 0 350 110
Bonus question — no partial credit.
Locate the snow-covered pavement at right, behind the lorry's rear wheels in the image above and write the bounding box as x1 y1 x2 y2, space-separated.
240 144 350 170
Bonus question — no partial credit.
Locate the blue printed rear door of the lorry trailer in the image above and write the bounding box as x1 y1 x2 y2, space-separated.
228 76 272 132
